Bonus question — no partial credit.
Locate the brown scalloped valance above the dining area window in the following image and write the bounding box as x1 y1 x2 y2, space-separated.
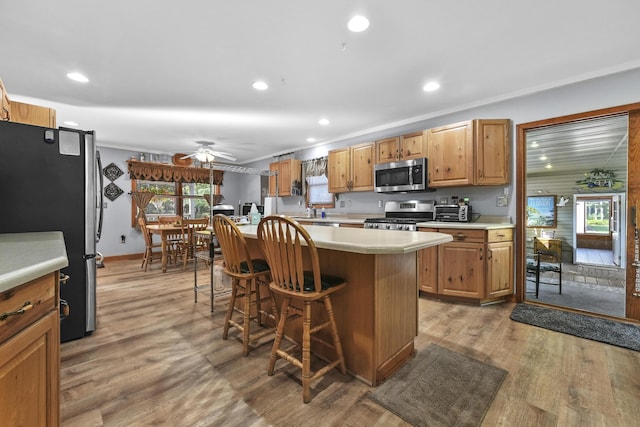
127 160 224 185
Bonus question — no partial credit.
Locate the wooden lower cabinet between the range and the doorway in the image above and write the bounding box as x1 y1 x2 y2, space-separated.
418 228 513 302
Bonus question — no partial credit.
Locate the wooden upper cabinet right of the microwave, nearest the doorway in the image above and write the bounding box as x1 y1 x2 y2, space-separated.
426 119 511 188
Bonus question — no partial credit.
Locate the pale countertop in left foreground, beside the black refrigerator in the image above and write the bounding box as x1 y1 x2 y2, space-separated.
0 231 69 292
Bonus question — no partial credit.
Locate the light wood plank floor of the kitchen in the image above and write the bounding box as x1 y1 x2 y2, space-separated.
61 261 640 427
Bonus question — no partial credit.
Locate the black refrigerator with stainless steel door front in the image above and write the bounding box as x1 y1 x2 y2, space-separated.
0 118 103 342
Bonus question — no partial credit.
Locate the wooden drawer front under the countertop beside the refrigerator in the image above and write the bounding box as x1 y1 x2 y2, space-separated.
0 272 58 343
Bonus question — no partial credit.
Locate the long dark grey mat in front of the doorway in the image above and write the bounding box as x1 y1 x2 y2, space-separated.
511 304 640 351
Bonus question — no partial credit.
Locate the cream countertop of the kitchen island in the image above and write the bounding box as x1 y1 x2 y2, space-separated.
240 225 453 254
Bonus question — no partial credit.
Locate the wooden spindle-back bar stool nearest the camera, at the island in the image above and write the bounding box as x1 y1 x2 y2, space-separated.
257 215 347 403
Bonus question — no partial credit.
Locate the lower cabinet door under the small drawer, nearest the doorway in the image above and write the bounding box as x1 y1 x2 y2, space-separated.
487 242 513 298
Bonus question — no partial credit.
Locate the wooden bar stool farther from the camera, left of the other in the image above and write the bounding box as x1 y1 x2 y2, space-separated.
213 214 278 356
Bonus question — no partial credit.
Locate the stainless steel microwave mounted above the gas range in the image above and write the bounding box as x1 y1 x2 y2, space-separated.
373 158 432 193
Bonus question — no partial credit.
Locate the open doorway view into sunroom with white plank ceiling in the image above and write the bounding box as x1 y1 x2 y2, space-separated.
522 113 629 317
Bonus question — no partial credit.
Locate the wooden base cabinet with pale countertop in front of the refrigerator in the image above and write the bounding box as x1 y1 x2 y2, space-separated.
0 231 69 426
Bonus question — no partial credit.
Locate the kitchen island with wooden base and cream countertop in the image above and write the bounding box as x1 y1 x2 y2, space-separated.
235 225 452 386
